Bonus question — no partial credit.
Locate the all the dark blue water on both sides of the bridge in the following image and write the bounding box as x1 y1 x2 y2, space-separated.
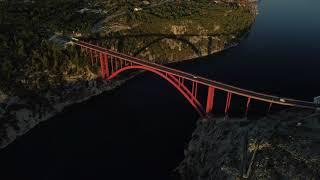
0 0 320 180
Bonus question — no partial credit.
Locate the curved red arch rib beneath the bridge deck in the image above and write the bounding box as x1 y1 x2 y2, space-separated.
108 65 205 116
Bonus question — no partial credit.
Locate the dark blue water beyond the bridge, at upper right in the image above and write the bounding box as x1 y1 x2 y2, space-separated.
175 0 320 100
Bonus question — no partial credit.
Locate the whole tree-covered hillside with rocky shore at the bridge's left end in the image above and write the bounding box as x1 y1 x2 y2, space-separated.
0 0 255 148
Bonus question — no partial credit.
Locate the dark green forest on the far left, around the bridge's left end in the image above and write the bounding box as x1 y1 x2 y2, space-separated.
0 0 101 94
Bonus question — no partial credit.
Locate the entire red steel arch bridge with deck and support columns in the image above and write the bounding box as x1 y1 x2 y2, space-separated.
71 38 318 116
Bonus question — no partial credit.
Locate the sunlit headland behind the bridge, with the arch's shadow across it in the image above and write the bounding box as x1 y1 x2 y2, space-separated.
95 0 255 63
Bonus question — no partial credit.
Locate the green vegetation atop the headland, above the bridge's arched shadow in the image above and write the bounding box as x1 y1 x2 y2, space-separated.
100 0 255 35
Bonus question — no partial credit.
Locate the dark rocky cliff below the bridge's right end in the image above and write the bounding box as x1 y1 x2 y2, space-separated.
178 109 320 180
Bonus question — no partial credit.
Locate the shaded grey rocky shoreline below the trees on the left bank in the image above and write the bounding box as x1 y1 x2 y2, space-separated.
0 77 126 149
